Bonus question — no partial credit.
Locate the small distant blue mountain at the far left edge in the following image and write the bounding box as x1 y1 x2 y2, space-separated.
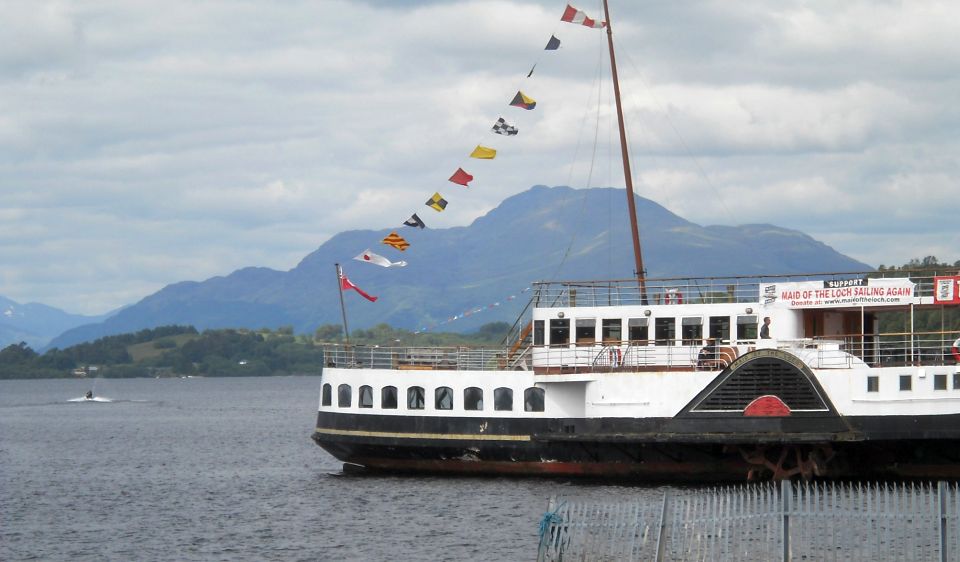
0 296 109 349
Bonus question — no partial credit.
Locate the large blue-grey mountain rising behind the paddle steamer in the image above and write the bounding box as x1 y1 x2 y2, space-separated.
51 186 872 347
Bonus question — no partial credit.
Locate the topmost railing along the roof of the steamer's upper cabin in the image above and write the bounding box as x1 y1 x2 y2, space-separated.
533 269 957 308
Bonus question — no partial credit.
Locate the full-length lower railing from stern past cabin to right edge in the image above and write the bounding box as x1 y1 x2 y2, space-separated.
324 331 960 372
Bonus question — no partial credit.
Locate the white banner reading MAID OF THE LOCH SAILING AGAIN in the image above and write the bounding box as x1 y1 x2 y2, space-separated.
760 277 919 308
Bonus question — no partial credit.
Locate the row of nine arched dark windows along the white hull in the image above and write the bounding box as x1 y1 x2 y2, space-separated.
320 383 544 412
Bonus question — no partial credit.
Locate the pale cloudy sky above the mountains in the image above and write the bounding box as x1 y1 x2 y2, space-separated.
0 0 960 314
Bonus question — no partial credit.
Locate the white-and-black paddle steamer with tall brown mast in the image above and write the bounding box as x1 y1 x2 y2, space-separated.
313 2 960 481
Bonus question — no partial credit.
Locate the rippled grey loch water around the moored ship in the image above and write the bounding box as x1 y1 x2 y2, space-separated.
0 377 660 561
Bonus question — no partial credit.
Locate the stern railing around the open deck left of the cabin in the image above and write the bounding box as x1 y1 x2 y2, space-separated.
323 344 525 371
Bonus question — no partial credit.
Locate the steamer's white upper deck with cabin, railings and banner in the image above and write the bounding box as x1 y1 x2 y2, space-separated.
327 271 960 373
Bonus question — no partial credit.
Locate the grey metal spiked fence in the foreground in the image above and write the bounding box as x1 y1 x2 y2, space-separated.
538 481 960 562
